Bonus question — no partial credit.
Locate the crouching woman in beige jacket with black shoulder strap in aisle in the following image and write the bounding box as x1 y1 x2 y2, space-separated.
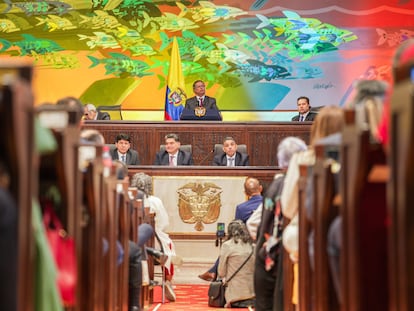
218 220 255 308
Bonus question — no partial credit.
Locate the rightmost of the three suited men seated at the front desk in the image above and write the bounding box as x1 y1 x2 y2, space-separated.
213 137 249 166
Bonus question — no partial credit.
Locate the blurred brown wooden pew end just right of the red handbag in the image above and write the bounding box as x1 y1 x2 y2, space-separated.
36 105 82 310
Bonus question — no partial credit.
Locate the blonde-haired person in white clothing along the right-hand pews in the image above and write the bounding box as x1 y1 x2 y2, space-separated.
281 106 345 304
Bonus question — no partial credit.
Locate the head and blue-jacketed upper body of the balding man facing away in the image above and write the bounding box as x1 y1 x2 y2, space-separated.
234 177 263 223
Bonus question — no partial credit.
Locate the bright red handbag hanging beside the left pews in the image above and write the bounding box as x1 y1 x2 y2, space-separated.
43 205 77 307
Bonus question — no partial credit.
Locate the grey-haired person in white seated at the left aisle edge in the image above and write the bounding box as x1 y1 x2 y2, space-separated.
131 173 176 301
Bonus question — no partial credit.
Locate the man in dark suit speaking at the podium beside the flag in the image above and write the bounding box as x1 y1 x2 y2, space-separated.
181 80 222 120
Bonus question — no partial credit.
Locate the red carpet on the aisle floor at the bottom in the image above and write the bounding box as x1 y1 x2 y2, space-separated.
148 284 252 311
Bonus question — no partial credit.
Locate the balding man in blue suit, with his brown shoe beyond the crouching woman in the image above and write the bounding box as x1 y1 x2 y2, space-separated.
198 177 263 282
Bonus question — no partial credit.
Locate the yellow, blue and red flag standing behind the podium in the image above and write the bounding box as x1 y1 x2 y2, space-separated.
164 37 186 120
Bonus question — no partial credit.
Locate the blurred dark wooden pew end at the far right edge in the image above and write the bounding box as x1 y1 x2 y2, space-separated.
387 62 414 311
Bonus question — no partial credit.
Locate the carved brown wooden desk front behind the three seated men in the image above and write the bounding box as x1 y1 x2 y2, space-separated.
83 121 312 166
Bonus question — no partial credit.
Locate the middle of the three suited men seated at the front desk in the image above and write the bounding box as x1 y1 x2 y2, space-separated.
154 133 194 166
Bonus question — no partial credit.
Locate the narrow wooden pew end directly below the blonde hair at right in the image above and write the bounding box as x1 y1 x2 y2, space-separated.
314 145 339 311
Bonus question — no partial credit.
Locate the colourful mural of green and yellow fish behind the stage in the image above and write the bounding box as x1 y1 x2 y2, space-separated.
0 0 414 119
